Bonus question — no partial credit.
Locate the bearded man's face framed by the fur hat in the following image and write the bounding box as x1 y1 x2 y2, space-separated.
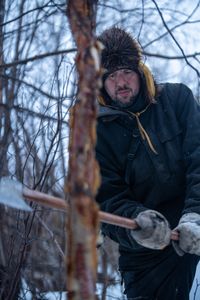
104 69 140 104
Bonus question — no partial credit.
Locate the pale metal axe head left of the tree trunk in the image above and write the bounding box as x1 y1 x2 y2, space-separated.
0 177 32 211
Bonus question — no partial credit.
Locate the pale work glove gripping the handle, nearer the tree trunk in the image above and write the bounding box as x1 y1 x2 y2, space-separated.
131 210 171 249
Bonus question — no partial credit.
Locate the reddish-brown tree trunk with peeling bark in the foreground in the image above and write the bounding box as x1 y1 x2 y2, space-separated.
66 0 101 300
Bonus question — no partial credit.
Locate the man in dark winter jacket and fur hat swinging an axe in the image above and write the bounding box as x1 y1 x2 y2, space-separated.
96 27 200 300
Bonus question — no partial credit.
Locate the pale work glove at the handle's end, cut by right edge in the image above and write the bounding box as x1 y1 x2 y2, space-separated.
172 213 200 256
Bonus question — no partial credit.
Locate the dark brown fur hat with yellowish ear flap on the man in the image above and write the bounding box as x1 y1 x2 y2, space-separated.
98 27 156 105
